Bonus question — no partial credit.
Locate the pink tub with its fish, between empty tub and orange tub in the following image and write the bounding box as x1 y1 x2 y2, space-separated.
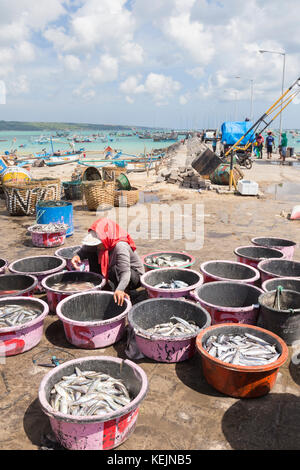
128 299 211 362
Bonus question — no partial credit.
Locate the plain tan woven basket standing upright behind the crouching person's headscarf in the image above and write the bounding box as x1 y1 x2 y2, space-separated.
82 181 115 211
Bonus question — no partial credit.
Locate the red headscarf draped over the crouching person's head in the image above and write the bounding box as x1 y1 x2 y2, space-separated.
89 219 136 279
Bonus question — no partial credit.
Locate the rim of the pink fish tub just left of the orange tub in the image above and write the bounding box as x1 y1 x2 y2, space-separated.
128 297 211 342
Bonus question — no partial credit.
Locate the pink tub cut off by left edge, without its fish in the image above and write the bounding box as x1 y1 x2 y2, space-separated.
0 297 49 356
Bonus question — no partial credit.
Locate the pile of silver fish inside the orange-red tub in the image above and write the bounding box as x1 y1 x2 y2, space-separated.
204 333 280 366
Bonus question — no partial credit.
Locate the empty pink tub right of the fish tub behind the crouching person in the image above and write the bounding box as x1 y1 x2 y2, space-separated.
200 261 260 284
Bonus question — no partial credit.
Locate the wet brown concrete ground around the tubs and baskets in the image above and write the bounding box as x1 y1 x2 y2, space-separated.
0 162 300 450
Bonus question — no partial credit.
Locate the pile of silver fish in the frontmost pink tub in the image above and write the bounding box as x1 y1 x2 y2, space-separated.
50 367 131 416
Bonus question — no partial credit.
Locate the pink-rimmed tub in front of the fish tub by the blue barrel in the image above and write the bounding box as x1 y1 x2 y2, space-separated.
8 256 66 293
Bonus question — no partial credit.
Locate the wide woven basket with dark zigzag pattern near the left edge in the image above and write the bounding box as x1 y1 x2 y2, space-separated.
3 178 61 216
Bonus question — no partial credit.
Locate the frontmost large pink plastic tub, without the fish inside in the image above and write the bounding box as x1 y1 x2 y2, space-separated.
39 356 148 450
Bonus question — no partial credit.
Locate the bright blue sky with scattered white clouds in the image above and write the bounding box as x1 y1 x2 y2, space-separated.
0 0 300 129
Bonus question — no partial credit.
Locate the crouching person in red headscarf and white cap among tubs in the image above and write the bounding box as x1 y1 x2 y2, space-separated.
72 218 144 305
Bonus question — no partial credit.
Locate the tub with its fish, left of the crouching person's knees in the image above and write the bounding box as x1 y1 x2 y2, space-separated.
42 271 106 313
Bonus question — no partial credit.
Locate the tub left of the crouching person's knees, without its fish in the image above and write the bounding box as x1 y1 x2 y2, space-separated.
42 271 106 313
